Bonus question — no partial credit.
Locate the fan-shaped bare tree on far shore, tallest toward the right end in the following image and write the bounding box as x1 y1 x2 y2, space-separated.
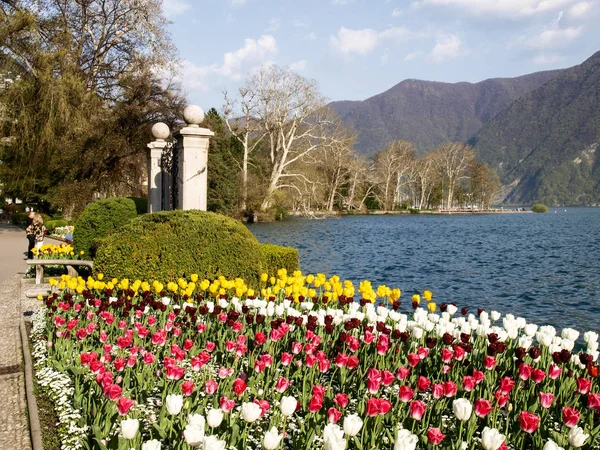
435 142 475 209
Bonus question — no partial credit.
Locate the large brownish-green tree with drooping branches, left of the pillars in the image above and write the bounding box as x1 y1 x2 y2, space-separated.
0 0 184 214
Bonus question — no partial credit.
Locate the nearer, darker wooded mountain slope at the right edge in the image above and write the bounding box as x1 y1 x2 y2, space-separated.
469 52 600 205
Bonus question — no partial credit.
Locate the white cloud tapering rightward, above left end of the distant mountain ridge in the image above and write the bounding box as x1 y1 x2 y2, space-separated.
329 27 412 55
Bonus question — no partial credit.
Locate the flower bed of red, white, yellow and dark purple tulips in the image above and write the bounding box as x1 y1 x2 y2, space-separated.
32 271 600 450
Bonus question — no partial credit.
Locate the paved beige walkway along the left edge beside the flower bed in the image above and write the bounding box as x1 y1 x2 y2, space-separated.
0 224 36 450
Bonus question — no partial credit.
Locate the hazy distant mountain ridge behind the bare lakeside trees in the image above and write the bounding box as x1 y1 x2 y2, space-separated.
331 70 561 155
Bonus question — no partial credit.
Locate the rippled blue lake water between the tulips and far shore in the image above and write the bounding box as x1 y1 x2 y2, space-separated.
249 208 600 331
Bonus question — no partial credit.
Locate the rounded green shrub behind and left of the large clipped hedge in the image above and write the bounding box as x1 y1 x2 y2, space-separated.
73 198 137 258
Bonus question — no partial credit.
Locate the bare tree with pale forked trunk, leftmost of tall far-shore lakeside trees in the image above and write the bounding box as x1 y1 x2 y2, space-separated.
375 140 414 211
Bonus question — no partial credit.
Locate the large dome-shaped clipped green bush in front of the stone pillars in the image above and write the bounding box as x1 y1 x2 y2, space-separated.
94 211 261 284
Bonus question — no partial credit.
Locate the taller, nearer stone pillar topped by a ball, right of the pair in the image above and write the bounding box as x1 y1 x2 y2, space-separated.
174 105 214 211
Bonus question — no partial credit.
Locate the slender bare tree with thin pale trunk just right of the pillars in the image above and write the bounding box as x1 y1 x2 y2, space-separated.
224 87 266 211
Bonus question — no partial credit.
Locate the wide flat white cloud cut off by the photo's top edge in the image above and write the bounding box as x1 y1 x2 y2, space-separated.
412 0 575 19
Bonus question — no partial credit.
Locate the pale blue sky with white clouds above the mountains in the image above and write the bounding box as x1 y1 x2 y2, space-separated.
163 0 600 110
